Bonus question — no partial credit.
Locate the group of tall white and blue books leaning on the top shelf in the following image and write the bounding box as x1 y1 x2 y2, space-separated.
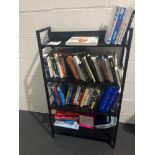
105 6 134 45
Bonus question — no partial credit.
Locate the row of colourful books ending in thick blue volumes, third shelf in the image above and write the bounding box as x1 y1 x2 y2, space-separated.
48 82 120 112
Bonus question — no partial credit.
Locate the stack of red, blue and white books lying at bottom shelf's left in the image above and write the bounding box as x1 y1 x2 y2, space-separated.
54 110 79 130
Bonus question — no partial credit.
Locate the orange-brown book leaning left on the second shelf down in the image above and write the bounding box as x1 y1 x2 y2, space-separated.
66 56 81 80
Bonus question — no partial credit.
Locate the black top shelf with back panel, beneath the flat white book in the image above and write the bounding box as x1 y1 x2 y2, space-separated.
41 31 127 49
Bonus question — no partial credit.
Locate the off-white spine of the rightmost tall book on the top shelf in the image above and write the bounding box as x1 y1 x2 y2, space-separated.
118 8 134 45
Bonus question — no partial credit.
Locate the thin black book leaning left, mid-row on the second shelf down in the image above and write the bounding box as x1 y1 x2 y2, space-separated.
86 55 100 82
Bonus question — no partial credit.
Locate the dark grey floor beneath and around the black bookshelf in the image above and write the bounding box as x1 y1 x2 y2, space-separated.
19 111 135 155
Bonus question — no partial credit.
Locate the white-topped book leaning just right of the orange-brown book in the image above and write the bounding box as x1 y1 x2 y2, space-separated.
73 55 86 81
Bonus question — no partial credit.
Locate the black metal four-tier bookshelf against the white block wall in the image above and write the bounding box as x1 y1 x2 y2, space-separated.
36 22 133 148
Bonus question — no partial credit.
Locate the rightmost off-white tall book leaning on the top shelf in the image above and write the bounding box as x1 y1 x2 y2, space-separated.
117 7 133 45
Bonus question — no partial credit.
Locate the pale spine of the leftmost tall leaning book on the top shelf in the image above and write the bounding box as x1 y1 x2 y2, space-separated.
105 7 119 44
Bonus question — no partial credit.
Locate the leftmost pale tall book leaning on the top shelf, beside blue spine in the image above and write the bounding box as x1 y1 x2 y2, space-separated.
106 6 120 44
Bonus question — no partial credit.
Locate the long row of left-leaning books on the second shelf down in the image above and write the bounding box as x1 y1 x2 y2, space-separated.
44 54 122 86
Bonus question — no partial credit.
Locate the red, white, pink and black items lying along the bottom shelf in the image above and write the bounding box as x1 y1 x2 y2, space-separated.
54 110 117 130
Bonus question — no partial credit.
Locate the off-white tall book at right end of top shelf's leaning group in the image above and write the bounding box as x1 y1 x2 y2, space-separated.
117 7 134 45
